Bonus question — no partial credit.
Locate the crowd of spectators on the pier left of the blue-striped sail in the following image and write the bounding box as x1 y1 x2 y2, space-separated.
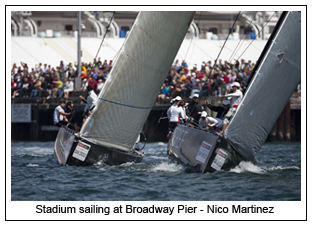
11 57 113 99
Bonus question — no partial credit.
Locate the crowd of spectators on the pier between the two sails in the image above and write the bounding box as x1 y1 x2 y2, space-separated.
157 59 255 103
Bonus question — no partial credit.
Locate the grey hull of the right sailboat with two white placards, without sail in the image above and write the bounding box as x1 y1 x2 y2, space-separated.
167 125 257 173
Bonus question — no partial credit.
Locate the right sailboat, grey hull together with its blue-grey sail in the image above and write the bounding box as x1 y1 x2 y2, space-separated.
167 12 301 173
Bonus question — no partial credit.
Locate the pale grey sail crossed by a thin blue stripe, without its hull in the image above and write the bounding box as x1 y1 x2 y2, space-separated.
81 11 195 151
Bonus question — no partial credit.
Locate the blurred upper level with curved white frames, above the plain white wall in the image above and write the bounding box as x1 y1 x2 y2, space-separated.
11 11 280 40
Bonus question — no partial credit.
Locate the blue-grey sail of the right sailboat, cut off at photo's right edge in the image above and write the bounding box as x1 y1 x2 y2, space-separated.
224 12 301 159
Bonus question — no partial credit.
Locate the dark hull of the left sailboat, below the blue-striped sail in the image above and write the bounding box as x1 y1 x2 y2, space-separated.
54 127 143 166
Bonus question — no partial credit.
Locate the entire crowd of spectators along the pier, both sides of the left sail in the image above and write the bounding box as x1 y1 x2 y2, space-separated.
11 57 254 103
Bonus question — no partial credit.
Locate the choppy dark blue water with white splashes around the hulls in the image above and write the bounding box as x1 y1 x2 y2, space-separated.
11 142 301 201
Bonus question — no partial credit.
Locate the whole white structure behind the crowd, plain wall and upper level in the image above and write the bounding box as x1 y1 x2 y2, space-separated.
11 11 280 70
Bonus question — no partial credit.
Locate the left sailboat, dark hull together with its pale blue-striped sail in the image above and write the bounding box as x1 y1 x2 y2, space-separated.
54 11 195 166
